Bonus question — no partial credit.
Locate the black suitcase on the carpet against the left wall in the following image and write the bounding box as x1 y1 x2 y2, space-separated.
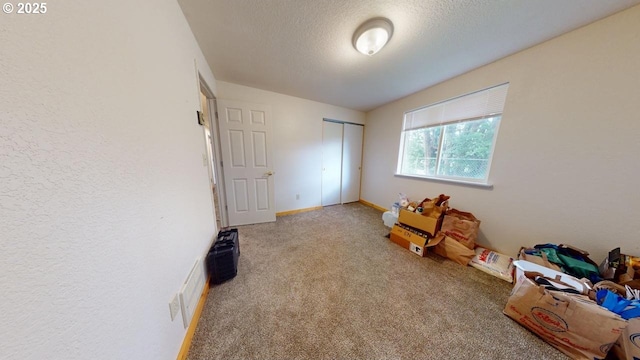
207 229 240 284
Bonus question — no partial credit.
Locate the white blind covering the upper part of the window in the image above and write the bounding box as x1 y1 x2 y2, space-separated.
402 83 509 131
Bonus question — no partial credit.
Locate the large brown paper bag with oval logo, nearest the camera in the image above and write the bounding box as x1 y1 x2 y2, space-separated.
503 277 627 359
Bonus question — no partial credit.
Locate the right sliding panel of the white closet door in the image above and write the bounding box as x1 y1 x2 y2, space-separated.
341 124 364 204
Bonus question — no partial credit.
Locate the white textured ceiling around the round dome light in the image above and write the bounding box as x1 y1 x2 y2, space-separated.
178 0 640 111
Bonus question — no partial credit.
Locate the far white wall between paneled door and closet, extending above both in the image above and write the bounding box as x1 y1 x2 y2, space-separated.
218 81 366 212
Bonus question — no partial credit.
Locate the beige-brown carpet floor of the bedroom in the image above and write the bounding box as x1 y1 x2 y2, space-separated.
188 203 567 360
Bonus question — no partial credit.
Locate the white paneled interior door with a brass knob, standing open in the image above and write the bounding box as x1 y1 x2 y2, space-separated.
218 100 276 226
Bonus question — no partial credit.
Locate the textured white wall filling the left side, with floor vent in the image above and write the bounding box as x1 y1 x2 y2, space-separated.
0 0 215 360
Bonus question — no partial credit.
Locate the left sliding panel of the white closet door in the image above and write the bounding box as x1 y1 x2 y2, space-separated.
322 121 343 206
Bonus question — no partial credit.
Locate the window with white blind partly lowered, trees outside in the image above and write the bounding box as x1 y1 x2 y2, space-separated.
397 84 509 184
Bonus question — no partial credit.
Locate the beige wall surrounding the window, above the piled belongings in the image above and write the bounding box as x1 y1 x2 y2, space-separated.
361 6 640 262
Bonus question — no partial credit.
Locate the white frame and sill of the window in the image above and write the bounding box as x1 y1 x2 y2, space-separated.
394 83 509 188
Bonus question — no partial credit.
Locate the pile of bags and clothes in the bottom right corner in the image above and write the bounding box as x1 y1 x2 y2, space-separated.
504 244 640 360
